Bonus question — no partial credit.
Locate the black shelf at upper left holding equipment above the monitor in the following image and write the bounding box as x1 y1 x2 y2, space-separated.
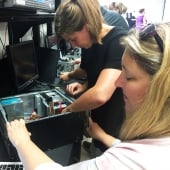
0 8 55 46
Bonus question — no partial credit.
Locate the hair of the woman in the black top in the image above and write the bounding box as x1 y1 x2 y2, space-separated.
55 0 104 43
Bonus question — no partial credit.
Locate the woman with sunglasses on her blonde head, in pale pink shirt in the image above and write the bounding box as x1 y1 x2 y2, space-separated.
7 23 170 170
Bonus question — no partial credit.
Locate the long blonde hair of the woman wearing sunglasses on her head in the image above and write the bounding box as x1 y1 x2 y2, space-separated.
120 23 170 140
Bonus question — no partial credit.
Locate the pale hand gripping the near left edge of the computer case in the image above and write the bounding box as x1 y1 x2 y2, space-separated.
6 119 31 147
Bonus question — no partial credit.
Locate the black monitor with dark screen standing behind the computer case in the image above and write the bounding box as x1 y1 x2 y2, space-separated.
7 40 39 91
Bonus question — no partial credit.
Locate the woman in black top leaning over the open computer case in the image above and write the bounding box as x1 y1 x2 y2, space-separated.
55 0 126 156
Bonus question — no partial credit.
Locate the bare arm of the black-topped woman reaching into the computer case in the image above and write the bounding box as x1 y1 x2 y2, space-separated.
65 69 121 112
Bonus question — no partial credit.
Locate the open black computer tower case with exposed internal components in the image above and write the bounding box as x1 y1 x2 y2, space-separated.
0 89 84 165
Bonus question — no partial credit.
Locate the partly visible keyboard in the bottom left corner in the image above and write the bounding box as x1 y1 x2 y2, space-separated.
0 162 24 170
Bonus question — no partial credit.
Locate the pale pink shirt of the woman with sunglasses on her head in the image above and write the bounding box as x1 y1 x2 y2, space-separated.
36 137 170 170
